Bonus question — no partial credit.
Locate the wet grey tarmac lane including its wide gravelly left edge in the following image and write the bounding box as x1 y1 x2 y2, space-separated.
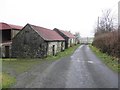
13 45 118 88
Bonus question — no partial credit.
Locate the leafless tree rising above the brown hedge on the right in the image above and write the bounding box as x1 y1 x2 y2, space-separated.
95 9 114 36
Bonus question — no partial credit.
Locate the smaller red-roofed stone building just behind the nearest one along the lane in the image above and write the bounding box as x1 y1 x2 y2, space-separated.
54 28 75 49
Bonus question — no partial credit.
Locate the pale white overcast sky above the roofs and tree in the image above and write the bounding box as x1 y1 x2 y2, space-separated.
0 0 119 37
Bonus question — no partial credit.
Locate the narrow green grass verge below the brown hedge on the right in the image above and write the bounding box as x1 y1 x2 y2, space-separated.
89 45 120 72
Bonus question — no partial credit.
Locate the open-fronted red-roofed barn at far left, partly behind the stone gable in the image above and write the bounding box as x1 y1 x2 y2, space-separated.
0 22 22 57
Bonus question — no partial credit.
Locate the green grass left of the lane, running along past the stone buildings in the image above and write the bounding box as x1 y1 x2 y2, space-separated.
1 44 80 88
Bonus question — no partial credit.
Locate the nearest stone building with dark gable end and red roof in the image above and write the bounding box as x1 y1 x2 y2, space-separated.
12 24 65 58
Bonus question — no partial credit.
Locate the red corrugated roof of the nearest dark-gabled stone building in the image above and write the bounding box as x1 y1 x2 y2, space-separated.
30 25 65 41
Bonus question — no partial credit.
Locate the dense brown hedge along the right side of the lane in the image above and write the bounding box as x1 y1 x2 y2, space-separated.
92 30 120 58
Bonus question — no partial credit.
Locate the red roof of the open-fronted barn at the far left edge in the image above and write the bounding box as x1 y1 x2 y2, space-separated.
0 22 23 30
